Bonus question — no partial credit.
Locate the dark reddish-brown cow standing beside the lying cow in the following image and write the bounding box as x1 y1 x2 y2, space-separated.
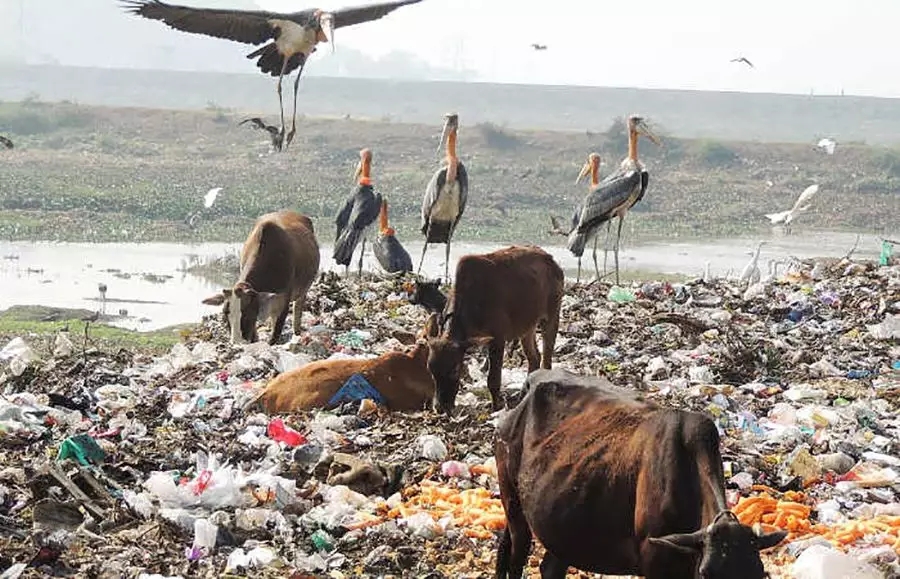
428 245 564 413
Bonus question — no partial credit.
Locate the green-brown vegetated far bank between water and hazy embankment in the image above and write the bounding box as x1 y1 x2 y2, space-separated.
0 97 900 243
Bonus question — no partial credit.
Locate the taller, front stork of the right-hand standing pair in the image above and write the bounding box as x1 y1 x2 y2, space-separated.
568 115 661 284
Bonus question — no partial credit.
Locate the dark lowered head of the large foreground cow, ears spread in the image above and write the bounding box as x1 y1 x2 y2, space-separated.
650 511 787 579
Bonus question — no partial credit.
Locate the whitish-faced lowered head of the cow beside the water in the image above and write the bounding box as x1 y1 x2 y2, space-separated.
203 282 288 344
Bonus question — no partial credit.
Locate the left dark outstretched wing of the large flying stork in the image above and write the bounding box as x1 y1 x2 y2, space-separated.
122 0 288 44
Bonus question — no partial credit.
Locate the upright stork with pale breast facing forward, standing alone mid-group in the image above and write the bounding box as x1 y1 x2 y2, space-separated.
416 113 469 279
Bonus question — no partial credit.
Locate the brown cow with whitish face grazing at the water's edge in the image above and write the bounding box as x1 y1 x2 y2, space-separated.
203 211 319 344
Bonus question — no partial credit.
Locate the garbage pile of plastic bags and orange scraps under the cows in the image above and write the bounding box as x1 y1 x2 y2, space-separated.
0 260 900 579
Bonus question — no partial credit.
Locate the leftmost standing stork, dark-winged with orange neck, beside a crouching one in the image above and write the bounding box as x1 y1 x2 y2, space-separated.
332 149 381 275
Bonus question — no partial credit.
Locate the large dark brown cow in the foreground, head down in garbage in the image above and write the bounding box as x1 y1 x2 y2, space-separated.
495 369 787 579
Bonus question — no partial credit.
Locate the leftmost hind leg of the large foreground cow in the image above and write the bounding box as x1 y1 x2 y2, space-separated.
495 442 532 579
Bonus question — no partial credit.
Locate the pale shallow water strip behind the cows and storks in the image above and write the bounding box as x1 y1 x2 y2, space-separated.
0 233 884 331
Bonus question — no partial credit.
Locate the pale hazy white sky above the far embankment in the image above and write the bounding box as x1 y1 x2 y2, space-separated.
255 0 900 97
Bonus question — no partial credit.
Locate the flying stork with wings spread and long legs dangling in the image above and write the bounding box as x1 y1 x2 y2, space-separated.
122 0 422 147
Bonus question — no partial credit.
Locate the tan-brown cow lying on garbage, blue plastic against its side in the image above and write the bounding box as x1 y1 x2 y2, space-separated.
251 341 434 414
